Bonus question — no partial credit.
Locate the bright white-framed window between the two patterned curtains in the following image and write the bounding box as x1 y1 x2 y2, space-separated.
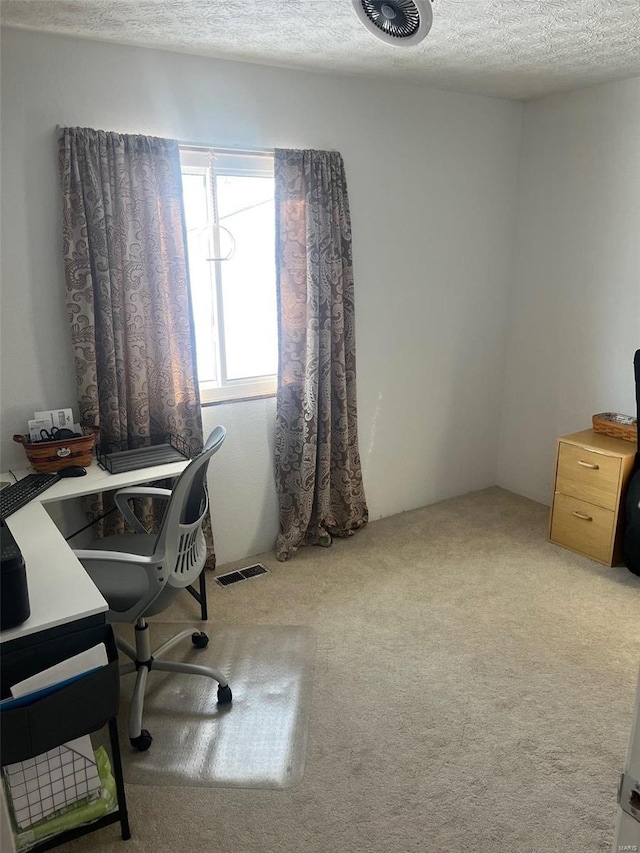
180 147 278 403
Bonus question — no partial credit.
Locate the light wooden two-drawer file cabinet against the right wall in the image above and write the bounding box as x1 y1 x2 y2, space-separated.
549 429 636 566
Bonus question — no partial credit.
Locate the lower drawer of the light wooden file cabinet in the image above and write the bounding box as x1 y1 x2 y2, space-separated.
549 492 616 564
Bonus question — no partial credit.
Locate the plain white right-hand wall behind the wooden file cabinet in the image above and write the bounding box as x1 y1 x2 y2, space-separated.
498 78 640 504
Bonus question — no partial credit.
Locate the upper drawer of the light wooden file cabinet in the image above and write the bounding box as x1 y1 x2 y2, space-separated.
556 441 621 510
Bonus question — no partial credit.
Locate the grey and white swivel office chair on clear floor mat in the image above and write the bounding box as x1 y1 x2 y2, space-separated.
75 426 232 751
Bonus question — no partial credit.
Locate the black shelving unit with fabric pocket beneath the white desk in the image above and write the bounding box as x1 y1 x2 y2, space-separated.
0 623 131 851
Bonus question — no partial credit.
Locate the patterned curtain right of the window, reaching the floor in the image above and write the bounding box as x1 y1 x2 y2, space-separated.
275 150 368 560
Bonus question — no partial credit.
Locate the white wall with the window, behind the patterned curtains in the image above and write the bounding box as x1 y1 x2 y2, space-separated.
0 30 522 562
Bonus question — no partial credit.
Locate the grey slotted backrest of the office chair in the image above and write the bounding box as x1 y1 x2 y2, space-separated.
155 426 227 587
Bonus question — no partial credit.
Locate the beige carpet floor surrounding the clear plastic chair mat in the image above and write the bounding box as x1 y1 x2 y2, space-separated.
68 489 640 853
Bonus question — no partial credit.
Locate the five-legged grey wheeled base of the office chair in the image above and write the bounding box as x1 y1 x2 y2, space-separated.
116 618 233 752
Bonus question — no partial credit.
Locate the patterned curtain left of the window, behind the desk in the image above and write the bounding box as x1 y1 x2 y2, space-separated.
59 127 212 560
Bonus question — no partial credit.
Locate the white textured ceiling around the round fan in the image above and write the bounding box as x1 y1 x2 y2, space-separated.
0 0 640 98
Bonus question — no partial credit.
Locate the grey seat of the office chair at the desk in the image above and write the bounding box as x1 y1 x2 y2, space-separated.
85 533 158 613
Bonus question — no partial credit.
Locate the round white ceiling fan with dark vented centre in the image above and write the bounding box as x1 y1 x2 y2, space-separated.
351 0 433 47
